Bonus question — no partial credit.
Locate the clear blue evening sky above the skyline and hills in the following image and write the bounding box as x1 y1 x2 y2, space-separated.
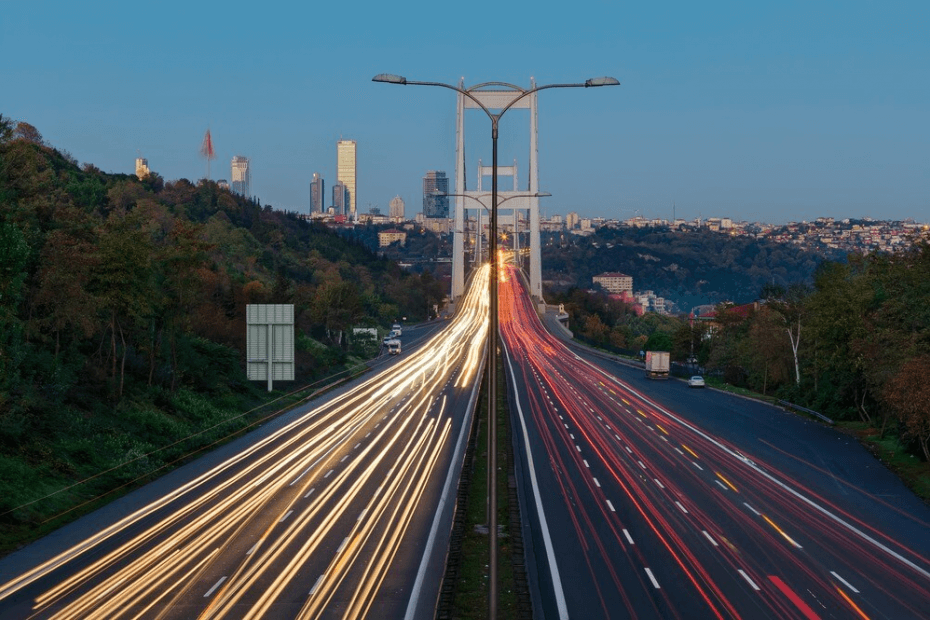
0 0 930 224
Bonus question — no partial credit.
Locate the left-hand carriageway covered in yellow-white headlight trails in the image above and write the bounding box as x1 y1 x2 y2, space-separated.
0 269 488 619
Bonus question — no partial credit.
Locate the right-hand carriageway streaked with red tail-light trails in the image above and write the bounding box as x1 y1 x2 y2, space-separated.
501 272 930 618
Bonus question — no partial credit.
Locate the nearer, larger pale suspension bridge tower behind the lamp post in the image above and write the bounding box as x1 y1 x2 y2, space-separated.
452 78 542 300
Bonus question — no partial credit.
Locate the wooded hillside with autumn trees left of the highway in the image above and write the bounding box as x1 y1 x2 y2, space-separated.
0 116 445 548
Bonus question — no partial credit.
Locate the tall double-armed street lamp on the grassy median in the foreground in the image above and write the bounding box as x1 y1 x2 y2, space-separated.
372 73 620 619
